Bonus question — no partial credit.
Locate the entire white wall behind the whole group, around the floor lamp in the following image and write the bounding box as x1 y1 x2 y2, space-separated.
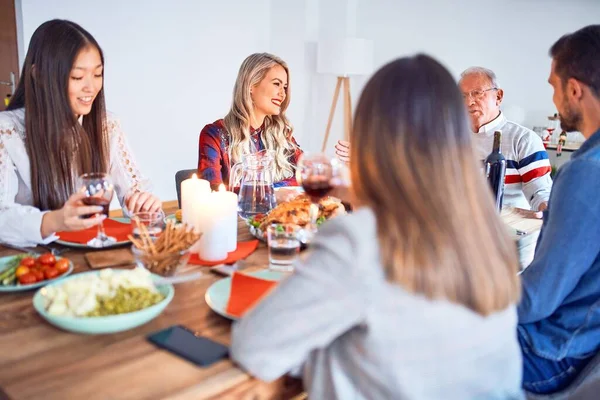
19 0 600 205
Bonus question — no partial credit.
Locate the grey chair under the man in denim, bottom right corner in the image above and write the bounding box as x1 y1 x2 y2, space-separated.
526 352 600 400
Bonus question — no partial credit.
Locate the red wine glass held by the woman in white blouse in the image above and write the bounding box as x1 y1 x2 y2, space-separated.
77 172 117 247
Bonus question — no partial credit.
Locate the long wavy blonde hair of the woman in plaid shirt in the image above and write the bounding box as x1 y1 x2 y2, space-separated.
223 53 297 181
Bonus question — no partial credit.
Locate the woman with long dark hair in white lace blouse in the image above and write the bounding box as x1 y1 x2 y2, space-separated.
0 20 161 245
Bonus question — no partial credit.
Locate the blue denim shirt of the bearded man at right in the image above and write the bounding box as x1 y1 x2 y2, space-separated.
518 130 600 360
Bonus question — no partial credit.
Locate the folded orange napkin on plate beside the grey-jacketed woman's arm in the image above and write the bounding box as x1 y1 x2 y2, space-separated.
226 272 279 318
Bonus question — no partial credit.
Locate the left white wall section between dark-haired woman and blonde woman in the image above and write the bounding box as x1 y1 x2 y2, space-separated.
21 0 270 205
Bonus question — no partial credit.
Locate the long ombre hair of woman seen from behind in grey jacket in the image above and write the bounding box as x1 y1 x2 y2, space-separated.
351 55 520 315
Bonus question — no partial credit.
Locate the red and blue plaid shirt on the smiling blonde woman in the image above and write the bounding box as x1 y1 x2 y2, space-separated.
198 119 302 189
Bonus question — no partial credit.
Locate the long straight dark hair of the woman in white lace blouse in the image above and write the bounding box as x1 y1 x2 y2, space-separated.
7 20 108 210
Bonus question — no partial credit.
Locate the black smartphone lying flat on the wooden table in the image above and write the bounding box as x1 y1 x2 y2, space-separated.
148 325 229 367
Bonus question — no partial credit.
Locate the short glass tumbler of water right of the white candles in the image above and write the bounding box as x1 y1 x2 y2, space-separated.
267 224 300 271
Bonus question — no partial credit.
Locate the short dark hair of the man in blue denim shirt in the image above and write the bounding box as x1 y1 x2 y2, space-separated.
550 25 600 98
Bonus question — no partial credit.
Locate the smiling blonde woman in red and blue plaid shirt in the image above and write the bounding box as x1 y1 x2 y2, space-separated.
198 53 302 187
